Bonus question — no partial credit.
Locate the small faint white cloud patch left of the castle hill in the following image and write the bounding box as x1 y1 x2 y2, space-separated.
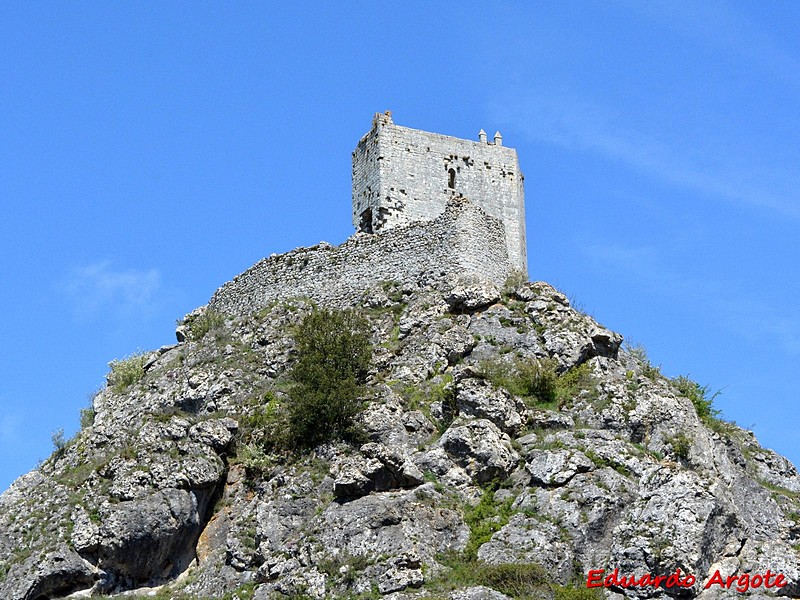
64 261 161 318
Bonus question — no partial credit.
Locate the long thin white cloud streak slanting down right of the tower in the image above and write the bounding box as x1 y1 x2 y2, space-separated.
491 92 800 219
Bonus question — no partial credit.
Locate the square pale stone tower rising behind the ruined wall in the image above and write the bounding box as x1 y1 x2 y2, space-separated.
353 111 528 275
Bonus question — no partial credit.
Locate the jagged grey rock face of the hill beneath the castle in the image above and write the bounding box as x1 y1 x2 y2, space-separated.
0 279 800 600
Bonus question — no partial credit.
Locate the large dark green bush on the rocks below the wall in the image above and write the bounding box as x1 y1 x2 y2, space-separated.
287 309 372 448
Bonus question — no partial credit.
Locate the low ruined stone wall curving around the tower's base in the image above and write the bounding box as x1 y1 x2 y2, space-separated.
209 198 509 314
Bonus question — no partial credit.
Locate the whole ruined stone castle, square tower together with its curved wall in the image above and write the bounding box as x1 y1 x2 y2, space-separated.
209 114 527 314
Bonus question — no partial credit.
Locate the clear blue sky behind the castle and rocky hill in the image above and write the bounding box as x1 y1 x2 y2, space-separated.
0 0 800 489
